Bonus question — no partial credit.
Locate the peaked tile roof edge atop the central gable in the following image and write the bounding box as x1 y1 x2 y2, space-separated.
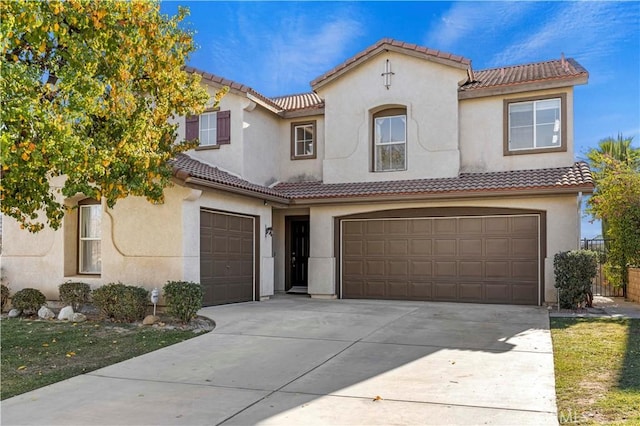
311 38 471 88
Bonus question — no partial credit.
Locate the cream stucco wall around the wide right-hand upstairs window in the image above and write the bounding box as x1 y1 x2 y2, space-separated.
460 87 574 172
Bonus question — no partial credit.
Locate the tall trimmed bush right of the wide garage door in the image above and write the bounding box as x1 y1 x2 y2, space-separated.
553 250 598 309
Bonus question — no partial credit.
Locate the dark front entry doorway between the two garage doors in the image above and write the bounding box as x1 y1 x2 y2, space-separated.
285 216 309 294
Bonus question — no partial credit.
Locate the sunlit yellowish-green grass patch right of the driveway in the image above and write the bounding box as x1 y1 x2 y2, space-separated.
551 318 640 425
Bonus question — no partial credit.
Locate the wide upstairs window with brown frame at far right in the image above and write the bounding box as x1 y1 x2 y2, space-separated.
505 94 566 155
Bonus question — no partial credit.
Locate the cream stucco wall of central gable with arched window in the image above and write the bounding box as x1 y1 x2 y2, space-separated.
318 52 466 183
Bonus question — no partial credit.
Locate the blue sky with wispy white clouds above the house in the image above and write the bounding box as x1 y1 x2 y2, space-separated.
162 1 640 237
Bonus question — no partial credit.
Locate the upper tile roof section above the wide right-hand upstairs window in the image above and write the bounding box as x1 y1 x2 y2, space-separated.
460 57 589 91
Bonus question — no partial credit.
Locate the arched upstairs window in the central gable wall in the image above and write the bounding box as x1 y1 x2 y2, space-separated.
373 108 407 172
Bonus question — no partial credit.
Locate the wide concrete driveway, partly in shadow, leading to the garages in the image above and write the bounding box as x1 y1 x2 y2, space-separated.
2 296 557 425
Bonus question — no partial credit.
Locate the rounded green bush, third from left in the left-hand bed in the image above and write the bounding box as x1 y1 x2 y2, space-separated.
91 283 149 322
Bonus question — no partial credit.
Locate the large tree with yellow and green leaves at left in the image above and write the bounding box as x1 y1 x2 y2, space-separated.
0 0 223 232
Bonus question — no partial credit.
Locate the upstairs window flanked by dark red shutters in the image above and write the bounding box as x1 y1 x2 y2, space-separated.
185 111 231 149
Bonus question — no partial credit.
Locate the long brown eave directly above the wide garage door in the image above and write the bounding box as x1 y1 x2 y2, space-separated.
290 185 594 207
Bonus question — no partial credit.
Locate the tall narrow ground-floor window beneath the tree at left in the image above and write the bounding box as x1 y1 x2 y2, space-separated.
78 199 102 274
